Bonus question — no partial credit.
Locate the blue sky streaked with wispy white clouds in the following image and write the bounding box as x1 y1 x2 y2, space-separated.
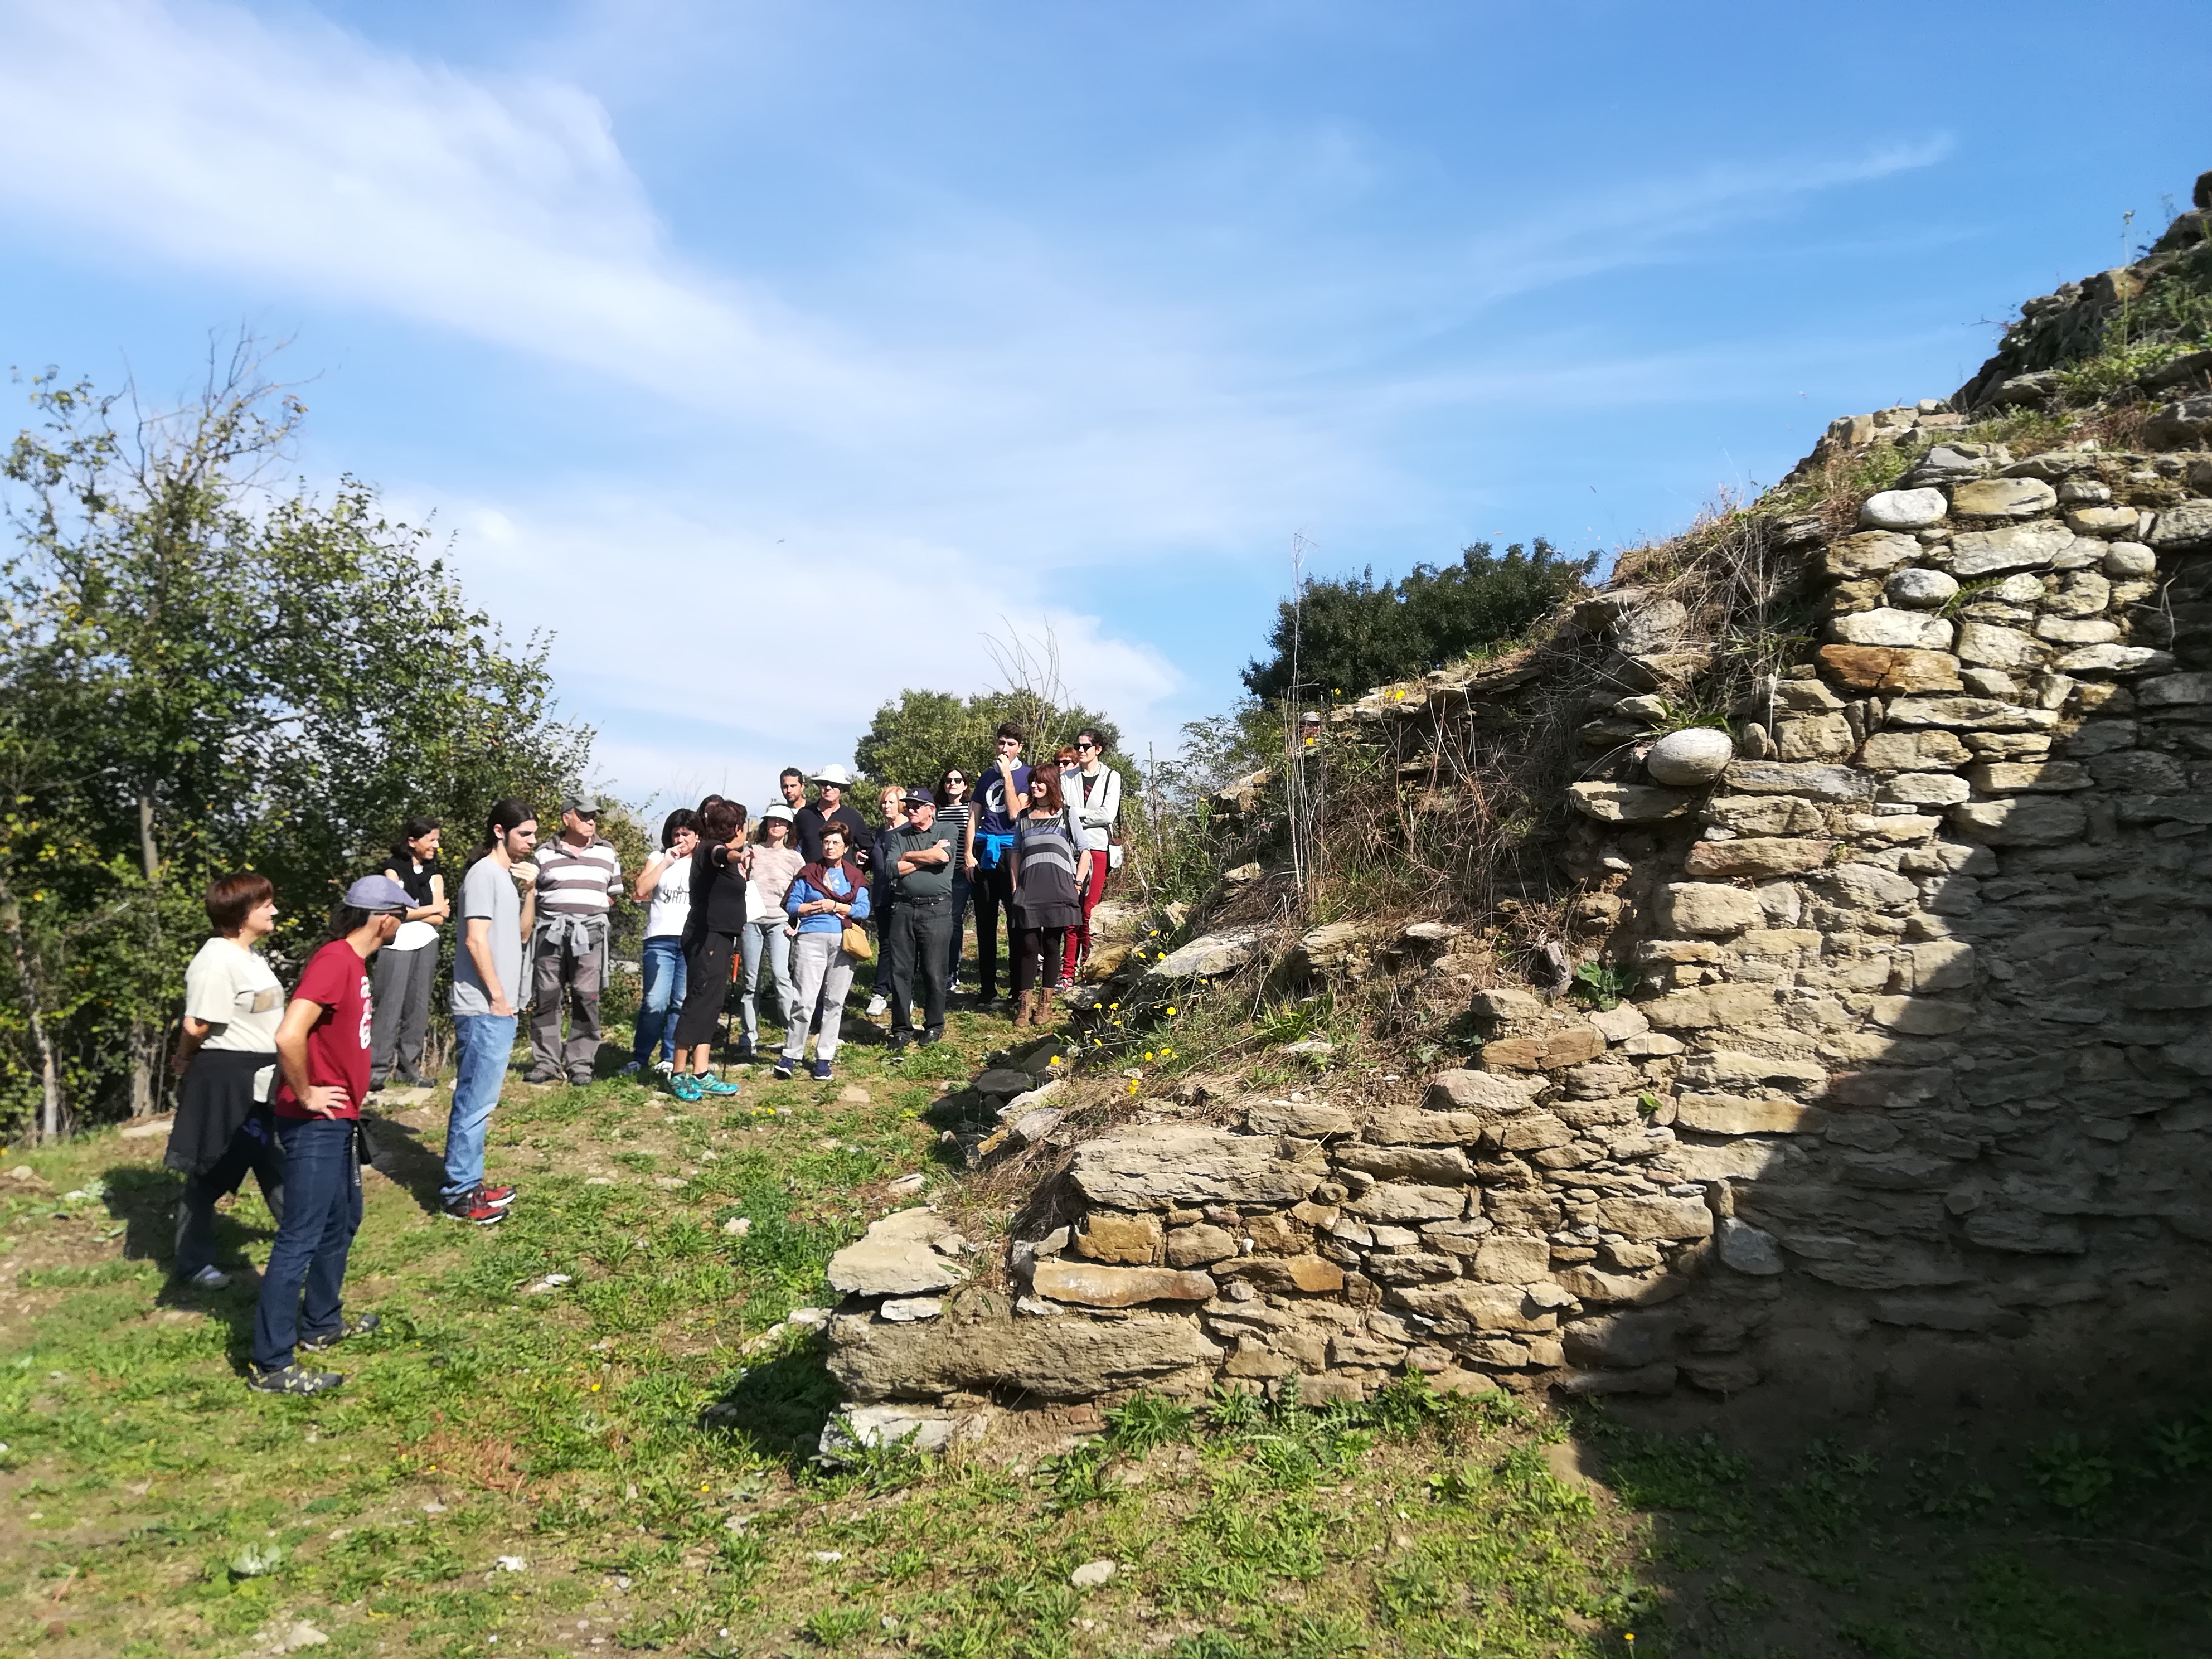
0 0 2212 798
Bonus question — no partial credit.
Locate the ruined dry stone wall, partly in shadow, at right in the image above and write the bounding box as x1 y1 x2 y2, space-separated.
832 283 2212 1433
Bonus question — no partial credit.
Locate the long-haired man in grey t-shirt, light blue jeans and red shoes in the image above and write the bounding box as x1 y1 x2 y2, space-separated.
443 801 537 1228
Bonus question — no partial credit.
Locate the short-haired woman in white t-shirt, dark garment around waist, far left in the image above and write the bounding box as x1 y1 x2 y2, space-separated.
162 871 283 1289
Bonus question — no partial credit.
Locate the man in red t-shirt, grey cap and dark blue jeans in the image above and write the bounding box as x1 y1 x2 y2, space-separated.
245 876 414 1394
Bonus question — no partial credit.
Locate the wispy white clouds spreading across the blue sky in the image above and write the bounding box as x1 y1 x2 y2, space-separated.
0 0 1940 796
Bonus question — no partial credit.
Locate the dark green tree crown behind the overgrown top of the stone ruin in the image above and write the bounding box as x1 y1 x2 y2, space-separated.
1243 535 1597 699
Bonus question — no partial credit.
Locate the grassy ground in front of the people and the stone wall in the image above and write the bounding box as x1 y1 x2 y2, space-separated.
0 986 2212 1659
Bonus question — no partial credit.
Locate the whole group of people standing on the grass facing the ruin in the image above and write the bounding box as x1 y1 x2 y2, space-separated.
166 724 1122 1394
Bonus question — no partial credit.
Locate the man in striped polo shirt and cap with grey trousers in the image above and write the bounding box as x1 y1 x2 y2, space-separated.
526 794 622 1084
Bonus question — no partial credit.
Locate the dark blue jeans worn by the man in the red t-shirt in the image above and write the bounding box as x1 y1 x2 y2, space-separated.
254 1117 361 1371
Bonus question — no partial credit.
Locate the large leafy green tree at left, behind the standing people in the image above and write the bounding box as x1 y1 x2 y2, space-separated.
0 338 590 1135
